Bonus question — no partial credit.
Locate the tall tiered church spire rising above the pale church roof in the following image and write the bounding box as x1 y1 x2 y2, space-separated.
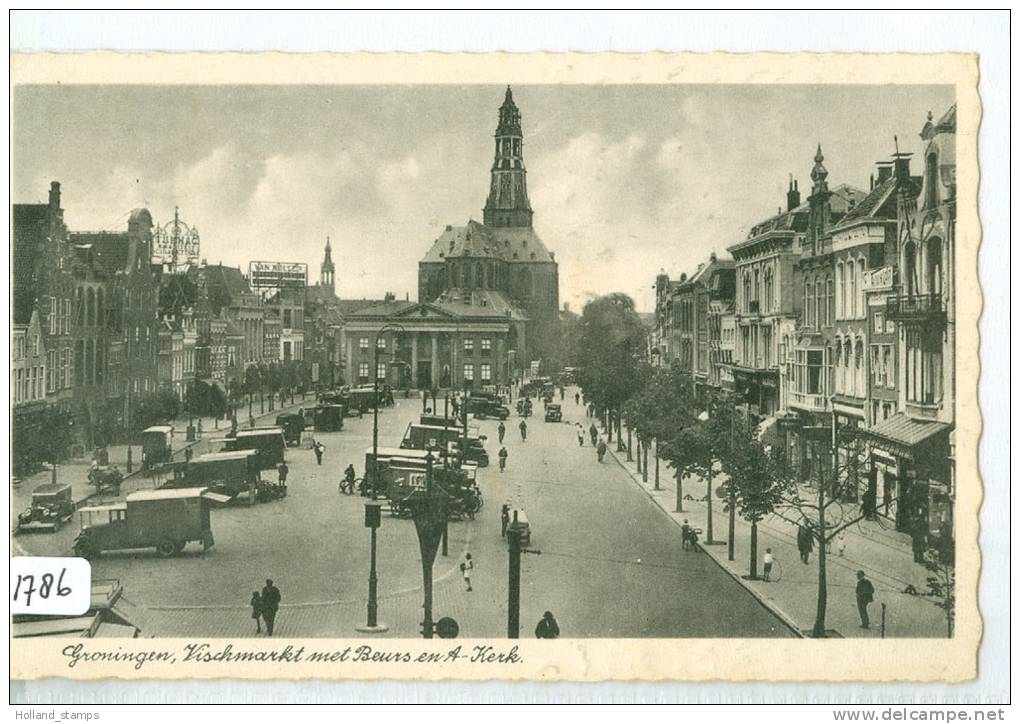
482 86 532 228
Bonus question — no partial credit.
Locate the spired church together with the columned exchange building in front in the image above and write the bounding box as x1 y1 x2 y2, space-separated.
344 88 559 389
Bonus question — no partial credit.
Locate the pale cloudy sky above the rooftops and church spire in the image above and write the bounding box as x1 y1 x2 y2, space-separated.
12 86 953 310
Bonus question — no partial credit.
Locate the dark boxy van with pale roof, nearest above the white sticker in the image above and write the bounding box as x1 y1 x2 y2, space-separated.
74 487 219 560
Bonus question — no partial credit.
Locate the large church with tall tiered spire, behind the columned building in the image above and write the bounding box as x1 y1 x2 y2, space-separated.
418 87 559 375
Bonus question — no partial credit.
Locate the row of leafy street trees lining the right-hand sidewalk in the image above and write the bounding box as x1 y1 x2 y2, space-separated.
570 294 953 636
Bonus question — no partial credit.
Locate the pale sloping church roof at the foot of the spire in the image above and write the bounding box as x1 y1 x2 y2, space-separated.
421 219 555 262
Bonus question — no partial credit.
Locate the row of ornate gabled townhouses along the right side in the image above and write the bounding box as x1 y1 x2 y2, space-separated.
651 106 956 554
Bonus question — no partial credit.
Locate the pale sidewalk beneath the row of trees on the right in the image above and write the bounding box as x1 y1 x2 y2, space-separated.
609 440 946 638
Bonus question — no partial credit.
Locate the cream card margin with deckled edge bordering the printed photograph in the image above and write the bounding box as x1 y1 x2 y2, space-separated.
11 52 982 682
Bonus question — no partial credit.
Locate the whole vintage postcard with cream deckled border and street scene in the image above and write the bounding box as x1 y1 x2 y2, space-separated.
10 53 982 682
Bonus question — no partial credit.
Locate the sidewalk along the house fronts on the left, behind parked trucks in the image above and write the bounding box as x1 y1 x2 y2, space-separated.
10 396 314 530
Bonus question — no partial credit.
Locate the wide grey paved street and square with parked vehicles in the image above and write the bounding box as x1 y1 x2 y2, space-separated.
17 390 792 637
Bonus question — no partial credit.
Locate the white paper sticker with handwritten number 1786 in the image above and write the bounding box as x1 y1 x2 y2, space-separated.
10 556 92 616
